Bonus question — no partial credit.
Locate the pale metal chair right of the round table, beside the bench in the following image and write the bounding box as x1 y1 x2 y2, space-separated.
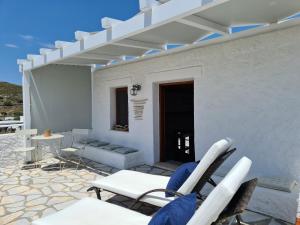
60 129 89 171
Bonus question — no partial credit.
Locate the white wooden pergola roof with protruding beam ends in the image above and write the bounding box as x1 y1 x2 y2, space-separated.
18 0 300 72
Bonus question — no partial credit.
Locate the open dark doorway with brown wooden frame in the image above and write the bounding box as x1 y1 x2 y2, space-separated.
159 81 195 162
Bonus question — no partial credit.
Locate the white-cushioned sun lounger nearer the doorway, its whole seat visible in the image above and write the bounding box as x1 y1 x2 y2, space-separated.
89 139 232 207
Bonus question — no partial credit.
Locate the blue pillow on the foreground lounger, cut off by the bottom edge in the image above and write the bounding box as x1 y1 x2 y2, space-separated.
149 193 197 225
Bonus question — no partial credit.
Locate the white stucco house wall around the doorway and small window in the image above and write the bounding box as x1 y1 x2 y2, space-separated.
92 26 300 180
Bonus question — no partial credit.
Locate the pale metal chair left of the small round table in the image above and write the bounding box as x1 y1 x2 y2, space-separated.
14 129 37 169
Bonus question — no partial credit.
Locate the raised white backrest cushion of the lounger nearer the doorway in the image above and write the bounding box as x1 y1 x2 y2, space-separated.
178 139 232 195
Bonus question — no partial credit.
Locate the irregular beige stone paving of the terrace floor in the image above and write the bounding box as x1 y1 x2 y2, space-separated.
0 135 286 225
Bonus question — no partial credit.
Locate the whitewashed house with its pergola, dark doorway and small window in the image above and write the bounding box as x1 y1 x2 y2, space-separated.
18 0 300 222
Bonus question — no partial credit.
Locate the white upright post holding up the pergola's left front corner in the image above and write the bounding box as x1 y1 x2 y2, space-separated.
23 71 31 129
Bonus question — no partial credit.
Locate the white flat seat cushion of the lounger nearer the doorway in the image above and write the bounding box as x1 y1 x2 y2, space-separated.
92 170 174 206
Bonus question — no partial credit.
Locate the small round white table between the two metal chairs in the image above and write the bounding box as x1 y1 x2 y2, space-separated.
31 134 64 161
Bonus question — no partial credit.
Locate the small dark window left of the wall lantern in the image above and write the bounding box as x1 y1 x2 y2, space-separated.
113 87 128 131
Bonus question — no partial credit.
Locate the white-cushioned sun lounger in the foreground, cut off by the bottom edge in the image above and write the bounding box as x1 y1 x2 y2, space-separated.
33 157 252 225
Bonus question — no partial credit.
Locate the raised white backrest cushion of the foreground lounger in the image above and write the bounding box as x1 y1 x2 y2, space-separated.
187 157 252 225
